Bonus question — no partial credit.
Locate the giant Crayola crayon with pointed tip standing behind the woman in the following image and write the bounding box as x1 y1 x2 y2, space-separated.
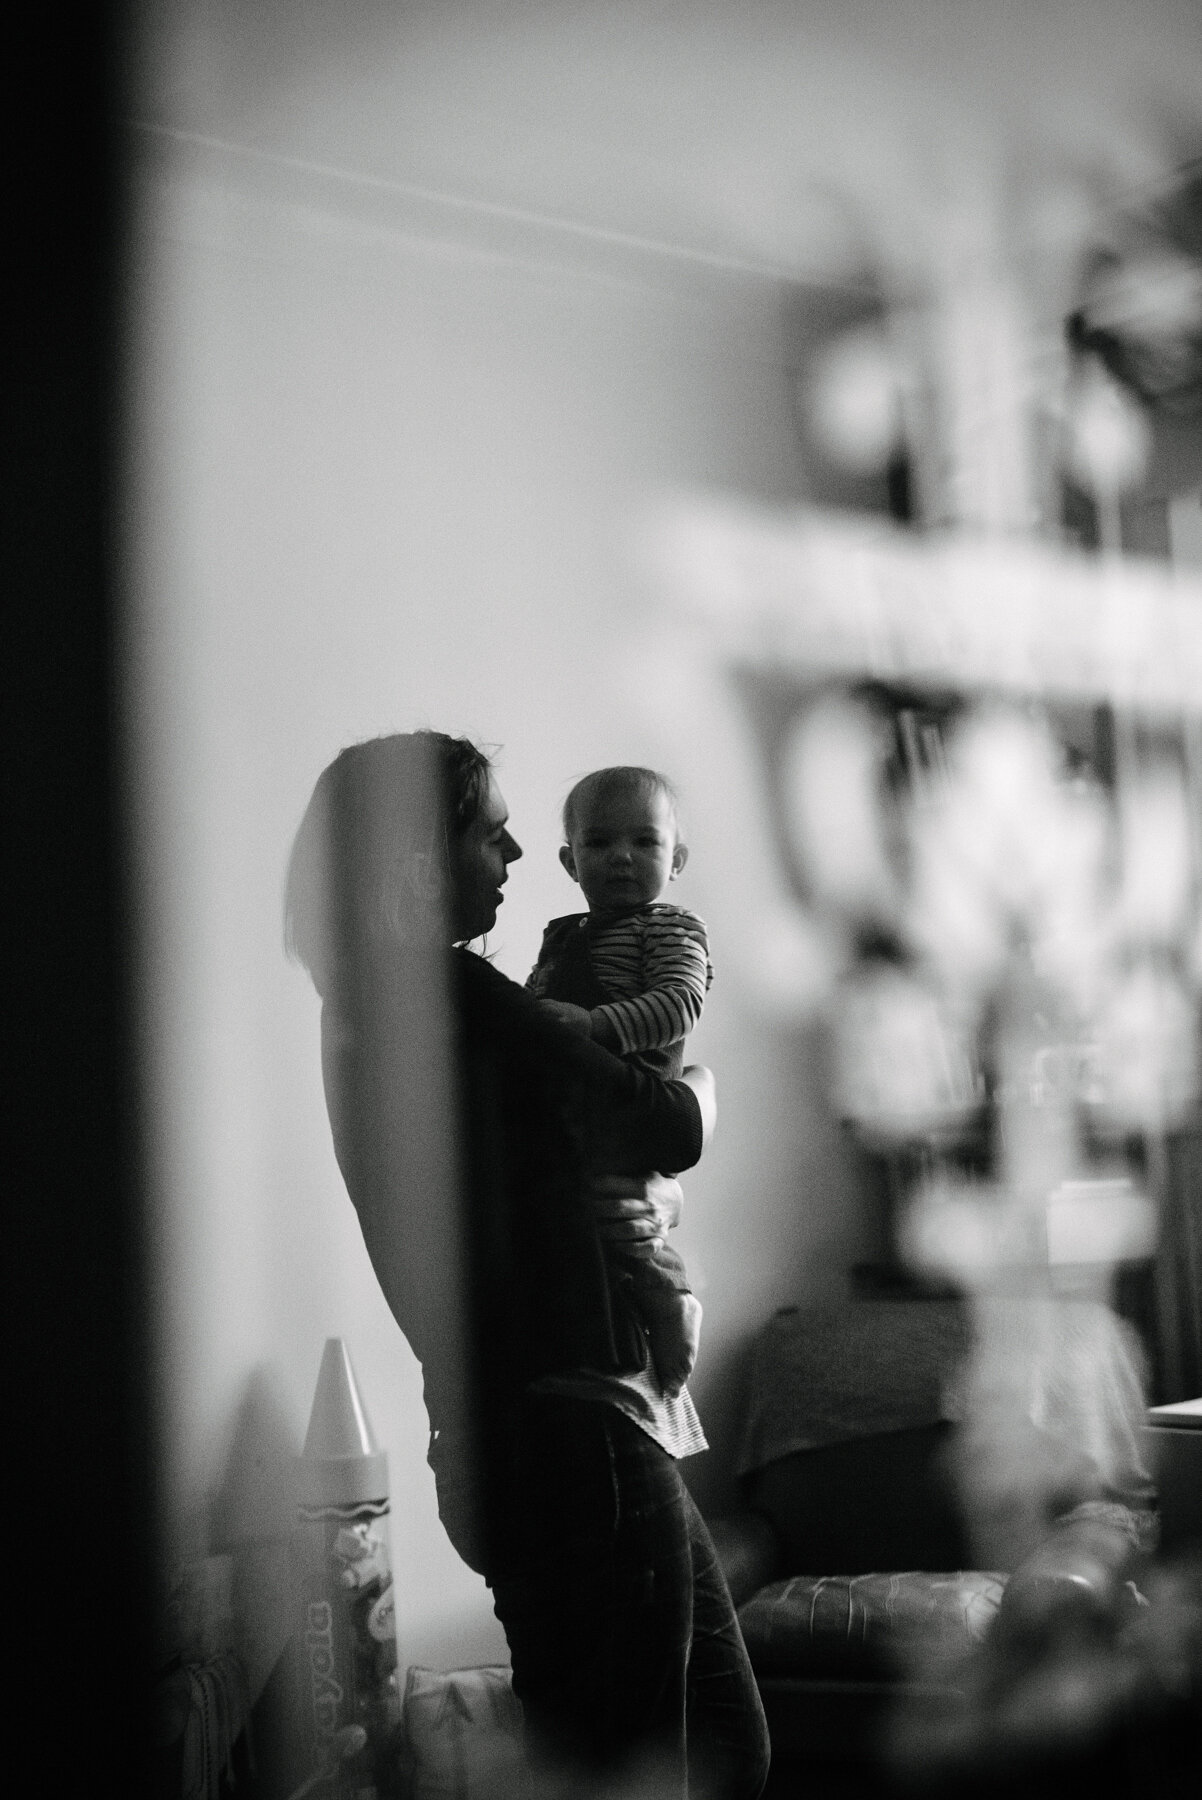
295 1337 399 1800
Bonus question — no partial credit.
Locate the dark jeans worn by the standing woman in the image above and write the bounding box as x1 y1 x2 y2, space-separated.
489 1397 768 1800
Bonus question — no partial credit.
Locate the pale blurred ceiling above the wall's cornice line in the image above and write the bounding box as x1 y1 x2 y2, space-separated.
133 0 1202 279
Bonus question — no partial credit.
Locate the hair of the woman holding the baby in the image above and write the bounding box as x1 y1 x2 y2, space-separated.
284 731 491 995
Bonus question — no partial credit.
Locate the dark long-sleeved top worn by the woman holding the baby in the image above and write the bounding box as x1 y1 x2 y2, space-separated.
322 950 702 1435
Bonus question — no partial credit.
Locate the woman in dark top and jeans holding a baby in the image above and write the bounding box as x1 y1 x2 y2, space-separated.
288 733 768 1800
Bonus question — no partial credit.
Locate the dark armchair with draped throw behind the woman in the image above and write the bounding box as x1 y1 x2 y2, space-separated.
709 1294 1155 1800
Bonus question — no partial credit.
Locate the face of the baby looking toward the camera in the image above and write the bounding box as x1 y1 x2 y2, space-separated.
560 794 687 913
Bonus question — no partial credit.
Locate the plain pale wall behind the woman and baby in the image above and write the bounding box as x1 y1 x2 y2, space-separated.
130 133 874 1665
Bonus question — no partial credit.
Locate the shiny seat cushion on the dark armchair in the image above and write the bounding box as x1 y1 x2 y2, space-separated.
740 1570 1006 1678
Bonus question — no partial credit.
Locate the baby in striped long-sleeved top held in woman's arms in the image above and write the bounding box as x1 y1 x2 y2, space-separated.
527 767 713 1393
